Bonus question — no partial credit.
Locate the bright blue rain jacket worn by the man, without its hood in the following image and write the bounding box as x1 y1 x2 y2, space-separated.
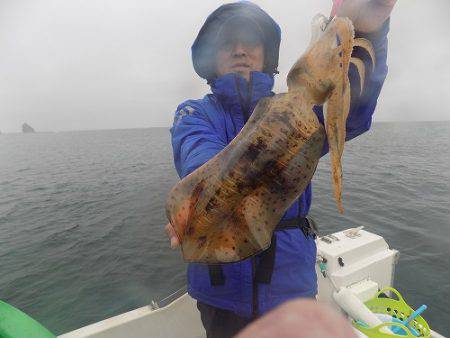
171 2 389 317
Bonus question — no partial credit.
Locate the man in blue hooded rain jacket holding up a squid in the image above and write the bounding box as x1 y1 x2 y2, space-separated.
166 0 395 338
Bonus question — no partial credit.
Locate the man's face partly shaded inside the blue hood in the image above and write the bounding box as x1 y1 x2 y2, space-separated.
216 41 264 81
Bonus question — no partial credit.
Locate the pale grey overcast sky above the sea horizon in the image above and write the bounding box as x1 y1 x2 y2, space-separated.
0 0 450 132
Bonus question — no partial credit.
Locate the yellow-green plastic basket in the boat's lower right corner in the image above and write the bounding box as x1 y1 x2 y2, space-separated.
353 288 431 338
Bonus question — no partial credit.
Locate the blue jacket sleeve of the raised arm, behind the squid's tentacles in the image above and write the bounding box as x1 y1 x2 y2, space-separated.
314 19 389 156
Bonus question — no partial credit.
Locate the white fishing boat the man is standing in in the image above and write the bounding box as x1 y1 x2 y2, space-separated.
0 227 445 338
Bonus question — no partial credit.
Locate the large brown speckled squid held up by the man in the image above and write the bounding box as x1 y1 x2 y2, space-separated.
166 16 373 264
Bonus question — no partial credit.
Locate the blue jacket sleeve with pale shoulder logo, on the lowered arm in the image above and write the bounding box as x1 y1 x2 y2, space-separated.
170 101 226 178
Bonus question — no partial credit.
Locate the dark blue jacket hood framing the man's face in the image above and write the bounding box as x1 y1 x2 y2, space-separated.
191 1 281 81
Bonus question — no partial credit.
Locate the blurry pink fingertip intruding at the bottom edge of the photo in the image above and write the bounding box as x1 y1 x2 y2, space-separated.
235 299 357 338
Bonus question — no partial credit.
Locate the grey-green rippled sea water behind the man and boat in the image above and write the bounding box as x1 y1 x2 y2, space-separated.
0 122 450 334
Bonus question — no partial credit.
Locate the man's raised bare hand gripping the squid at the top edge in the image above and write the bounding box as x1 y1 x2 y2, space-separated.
336 0 397 33
